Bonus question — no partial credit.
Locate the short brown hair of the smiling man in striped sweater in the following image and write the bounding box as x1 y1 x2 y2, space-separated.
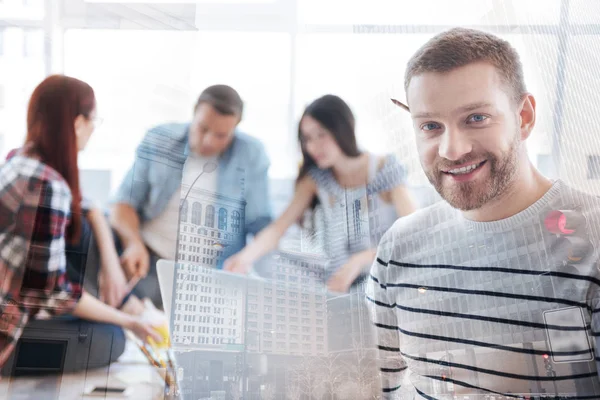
404 28 527 103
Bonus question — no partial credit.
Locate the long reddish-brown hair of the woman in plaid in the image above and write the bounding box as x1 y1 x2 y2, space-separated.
25 75 96 242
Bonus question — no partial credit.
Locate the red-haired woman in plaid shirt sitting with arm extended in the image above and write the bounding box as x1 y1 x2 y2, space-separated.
0 75 161 366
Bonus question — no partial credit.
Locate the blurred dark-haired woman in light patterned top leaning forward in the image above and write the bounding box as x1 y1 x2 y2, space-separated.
225 95 416 292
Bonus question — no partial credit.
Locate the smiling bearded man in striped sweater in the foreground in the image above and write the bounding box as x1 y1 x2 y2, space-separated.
367 28 600 399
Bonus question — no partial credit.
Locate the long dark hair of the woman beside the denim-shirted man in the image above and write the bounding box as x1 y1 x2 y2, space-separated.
296 94 361 210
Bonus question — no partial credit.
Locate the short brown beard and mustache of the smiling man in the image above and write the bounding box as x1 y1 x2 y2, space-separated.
425 135 520 211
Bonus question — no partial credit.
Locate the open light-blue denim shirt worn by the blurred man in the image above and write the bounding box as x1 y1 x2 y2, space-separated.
111 120 272 260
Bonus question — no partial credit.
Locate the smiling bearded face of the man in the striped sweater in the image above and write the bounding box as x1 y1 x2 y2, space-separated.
408 63 526 211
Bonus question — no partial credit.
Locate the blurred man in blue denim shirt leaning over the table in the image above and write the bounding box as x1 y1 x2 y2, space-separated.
111 85 272 304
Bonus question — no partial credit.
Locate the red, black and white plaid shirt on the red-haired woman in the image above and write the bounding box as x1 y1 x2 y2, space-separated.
0 155 82 366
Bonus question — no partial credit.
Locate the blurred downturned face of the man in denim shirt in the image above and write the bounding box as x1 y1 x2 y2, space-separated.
189 103 240 157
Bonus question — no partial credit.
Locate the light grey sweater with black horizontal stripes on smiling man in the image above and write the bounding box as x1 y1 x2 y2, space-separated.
366 180 600 400
